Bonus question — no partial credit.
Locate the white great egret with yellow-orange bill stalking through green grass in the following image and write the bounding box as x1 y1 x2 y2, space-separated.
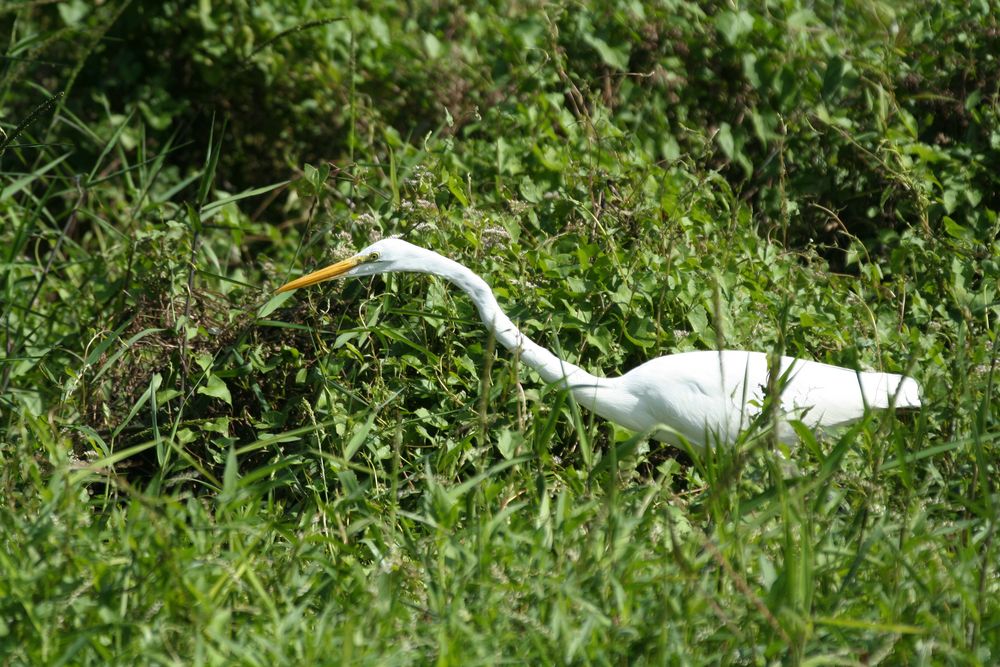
278 239 920 448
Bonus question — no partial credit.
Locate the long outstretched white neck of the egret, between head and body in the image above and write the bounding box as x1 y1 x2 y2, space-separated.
428 251 605 388
